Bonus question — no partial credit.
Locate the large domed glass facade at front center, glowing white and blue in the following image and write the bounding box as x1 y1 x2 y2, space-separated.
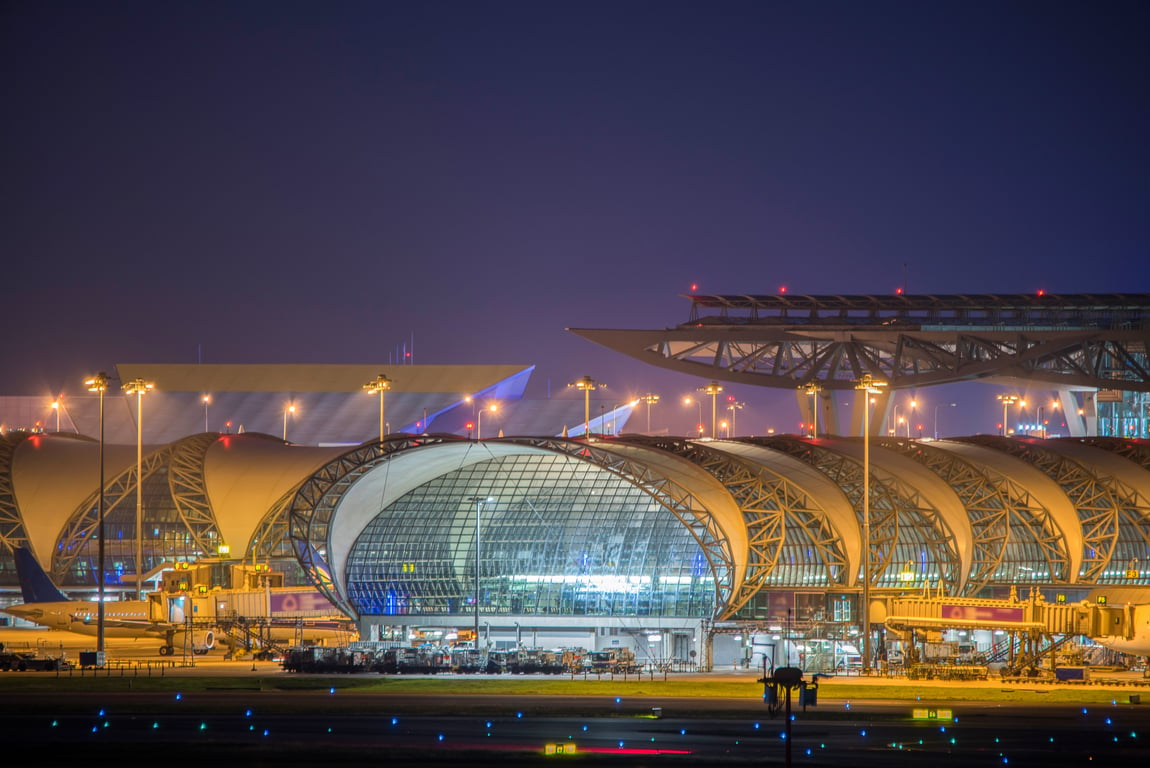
346 454 716 617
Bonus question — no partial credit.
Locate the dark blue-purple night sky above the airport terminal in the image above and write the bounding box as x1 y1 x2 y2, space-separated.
0 0 1150 432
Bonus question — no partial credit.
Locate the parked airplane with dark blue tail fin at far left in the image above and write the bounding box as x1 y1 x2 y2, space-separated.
3 547 216 656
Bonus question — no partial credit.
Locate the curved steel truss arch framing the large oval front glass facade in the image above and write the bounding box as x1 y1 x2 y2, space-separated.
288 436 735 616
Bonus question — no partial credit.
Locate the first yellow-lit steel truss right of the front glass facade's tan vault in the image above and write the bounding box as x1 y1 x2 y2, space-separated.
623 435 848 620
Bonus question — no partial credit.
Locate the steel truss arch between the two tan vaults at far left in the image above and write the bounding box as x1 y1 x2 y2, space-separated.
52 432 221 579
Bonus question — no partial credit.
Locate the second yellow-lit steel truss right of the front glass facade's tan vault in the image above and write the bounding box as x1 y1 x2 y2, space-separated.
739 435 965 593
